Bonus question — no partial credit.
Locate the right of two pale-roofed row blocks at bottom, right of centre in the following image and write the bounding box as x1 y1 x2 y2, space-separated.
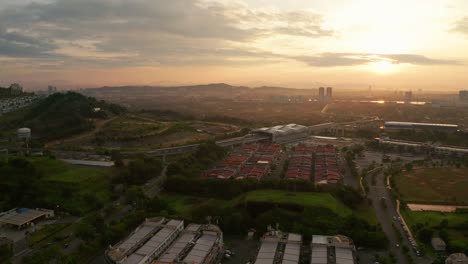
310 235 357 264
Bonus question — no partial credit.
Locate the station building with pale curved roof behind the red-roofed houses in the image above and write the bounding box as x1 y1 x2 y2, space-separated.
252 124 310 144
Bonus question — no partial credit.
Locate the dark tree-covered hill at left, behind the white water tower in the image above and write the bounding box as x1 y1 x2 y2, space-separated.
0 92 125 140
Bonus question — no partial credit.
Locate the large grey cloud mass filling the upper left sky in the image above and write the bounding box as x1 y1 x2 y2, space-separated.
0 0 334 66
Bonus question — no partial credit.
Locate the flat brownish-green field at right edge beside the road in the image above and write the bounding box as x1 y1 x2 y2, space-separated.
394 168 468 204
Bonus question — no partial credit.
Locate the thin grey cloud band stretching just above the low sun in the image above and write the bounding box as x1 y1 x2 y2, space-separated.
290 53 460 67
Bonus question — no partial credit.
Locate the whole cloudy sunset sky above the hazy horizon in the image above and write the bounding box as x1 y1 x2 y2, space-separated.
0 0 468 90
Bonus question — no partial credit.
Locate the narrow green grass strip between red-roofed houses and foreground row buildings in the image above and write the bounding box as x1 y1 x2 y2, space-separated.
244 190 351 216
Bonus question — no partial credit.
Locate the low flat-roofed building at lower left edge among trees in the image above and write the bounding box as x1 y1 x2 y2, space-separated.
0 208 55 229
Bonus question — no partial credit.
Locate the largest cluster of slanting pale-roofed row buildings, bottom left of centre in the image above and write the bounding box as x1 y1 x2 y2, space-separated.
105 217 224 264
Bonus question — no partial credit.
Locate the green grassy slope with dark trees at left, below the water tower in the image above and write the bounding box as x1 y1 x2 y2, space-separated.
0 157 114 214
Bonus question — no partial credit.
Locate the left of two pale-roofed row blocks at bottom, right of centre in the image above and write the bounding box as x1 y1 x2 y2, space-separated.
254 231 302 264
